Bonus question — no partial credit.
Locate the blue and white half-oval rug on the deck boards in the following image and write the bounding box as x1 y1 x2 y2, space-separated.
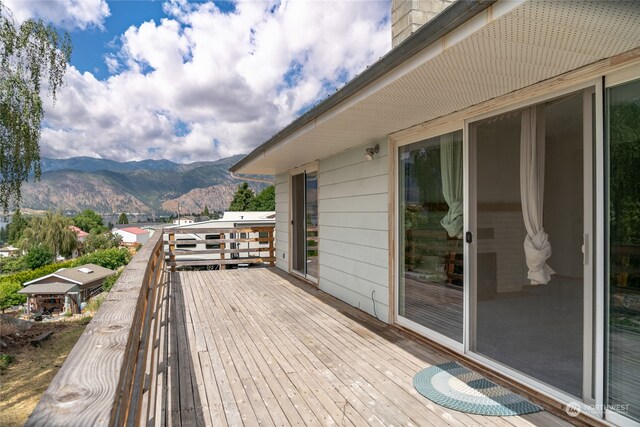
413 362 542 416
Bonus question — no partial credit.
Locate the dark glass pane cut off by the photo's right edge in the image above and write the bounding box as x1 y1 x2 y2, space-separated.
606 80 640 422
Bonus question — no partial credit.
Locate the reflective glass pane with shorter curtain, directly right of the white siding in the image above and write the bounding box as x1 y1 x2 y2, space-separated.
398 131 464 343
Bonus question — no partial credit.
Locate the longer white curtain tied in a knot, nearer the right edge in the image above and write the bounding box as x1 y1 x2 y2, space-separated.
520 107 555 285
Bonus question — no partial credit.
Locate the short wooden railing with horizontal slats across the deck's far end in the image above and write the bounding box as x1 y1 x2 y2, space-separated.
165 225 276 271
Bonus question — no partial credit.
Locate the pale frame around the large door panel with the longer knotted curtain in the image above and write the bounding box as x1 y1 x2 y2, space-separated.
463 78 605 418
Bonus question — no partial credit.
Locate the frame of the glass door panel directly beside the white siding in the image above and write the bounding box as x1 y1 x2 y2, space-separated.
390 120 469 354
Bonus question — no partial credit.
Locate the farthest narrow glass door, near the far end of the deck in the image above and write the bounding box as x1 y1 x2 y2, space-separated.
291 171 319 280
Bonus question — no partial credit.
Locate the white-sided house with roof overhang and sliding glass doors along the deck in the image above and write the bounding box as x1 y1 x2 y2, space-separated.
231 0 640 425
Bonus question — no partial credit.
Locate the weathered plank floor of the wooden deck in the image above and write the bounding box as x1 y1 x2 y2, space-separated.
159 268 567 426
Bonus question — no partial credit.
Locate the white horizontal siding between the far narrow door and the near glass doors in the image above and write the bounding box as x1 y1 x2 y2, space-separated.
318 141 389 321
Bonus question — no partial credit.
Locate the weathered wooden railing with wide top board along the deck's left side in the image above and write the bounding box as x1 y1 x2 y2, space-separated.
24 231 168 426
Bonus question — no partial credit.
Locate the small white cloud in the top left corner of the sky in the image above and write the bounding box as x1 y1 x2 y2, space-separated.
3 0 110 30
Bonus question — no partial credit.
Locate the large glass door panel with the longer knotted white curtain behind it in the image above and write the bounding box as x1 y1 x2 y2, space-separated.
470 89 594 402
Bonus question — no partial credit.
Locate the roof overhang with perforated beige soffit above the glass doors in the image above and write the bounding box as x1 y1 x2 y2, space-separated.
231 0 640 175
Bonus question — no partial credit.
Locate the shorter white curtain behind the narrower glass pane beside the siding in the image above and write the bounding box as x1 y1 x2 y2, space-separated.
440 133 464 239
